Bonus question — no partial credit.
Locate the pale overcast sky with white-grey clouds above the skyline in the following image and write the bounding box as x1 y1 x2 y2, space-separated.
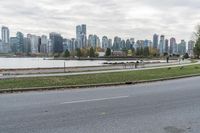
0 0 200 41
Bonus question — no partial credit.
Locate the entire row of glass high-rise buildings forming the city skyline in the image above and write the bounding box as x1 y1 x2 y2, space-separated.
0 24 195 56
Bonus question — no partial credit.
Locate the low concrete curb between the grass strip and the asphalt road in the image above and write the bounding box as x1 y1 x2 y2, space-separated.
0 74 200 94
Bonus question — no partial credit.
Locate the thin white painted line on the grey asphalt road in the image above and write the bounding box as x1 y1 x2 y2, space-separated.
61 96 129 104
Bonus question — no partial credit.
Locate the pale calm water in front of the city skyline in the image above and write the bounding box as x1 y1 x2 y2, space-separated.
0 58 166 69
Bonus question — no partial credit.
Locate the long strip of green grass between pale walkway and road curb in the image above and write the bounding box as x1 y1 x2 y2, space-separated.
0 65 200 89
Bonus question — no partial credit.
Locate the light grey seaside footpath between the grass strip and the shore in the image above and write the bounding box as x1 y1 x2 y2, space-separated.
0 60 195 79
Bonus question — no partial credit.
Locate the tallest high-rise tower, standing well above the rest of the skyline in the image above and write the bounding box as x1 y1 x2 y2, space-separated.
76 24 87 48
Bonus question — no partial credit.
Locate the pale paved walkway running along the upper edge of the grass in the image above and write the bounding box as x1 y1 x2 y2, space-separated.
0 61 194 79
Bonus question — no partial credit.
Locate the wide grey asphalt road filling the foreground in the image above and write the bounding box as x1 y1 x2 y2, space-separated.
0 77 200 133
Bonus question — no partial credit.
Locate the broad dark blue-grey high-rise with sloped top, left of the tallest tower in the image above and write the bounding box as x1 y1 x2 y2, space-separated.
49 32 63 53
